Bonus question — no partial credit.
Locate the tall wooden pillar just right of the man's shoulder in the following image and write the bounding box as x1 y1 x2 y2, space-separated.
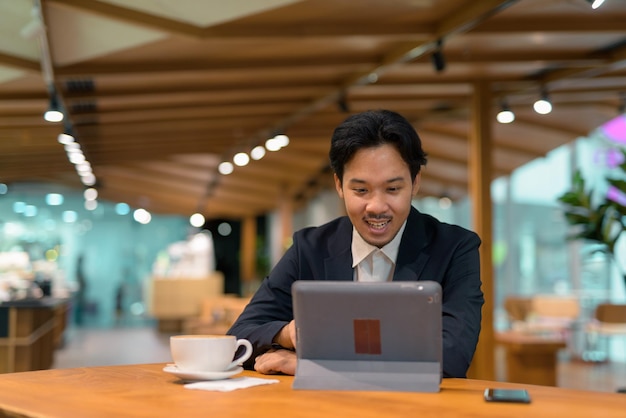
468 81 495 380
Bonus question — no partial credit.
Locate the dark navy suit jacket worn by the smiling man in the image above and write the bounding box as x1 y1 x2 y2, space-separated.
228 208 484 377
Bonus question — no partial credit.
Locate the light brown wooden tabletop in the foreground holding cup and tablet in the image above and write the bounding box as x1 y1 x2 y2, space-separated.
0 364 626 418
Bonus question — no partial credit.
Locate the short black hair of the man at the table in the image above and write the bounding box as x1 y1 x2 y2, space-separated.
329 110 427 182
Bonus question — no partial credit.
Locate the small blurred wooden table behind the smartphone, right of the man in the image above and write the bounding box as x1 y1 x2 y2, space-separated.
495 331 566 386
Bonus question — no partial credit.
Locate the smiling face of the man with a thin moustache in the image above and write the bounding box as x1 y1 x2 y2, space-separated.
335 144 420 248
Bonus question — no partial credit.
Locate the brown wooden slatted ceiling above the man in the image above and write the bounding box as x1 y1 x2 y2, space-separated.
0 0 626 218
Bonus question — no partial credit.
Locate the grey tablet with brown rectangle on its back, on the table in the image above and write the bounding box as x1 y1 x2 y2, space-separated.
292 280 442 392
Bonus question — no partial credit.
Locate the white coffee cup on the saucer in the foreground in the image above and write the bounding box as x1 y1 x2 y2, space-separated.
170 335 252 372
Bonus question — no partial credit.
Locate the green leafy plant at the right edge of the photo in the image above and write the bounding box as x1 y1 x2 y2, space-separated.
558 149 626 286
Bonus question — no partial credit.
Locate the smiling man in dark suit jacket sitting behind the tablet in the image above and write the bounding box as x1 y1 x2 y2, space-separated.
228 110 484 377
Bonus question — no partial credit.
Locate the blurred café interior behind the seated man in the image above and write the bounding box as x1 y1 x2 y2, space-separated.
0 0 626 391
